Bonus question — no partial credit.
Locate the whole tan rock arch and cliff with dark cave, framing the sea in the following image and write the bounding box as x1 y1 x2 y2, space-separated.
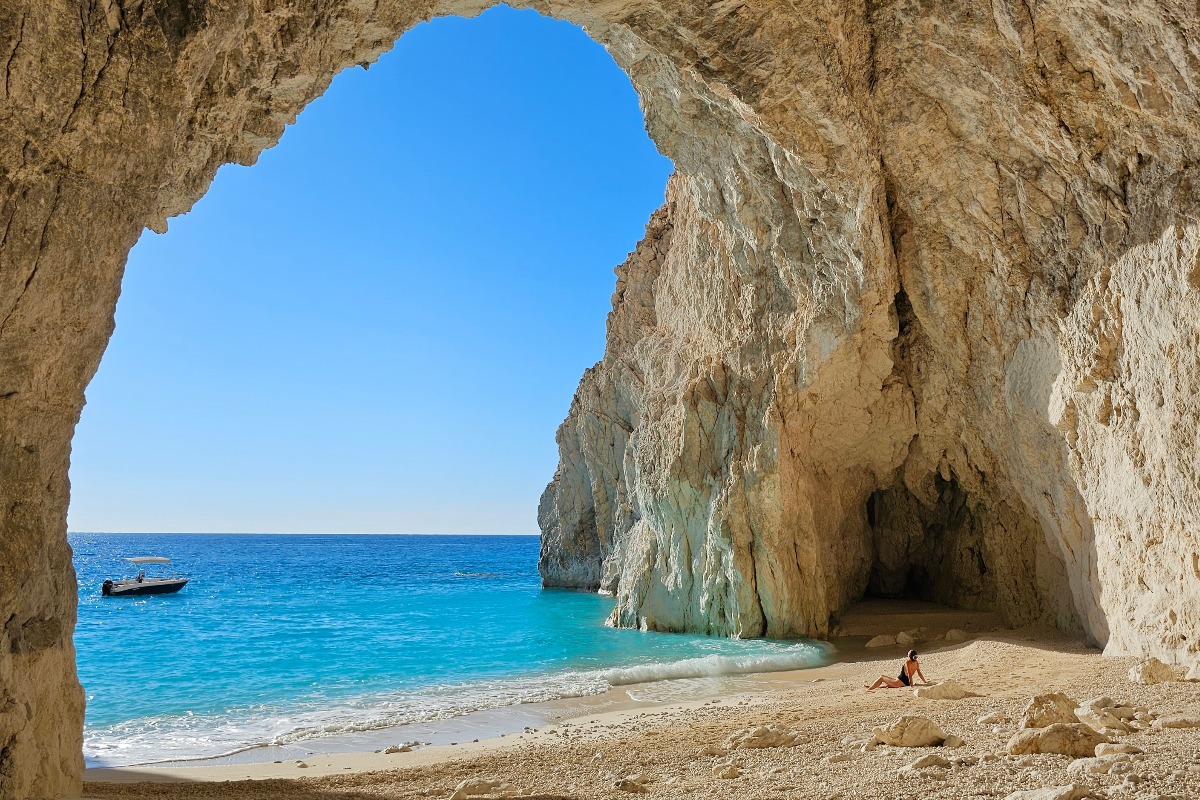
0 0 1200 798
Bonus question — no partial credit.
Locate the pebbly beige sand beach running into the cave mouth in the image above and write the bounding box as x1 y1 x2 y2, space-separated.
84 603 1200 800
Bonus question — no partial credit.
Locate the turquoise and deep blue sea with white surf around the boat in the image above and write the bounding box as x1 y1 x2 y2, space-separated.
70 534 823 765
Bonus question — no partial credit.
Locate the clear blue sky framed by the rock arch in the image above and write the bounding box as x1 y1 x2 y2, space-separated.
68 8 671 534
